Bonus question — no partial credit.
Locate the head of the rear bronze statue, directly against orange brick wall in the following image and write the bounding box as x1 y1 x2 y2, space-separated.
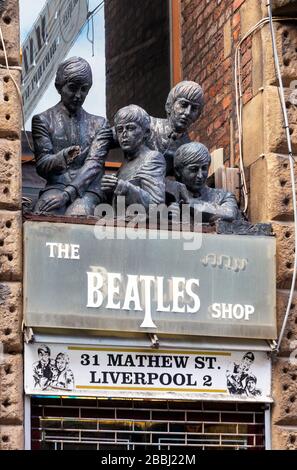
165 81 204 133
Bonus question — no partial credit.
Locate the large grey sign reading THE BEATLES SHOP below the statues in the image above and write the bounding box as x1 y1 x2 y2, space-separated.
24 222 276 339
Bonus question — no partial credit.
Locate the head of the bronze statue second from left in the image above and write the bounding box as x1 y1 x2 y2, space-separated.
114 104 150 152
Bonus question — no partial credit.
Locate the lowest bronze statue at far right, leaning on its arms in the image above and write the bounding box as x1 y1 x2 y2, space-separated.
166 142 241 223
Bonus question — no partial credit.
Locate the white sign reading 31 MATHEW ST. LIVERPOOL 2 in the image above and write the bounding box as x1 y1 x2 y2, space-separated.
25 343 271 401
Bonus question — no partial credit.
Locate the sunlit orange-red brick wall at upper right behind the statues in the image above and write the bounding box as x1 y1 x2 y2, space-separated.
181 0 252 165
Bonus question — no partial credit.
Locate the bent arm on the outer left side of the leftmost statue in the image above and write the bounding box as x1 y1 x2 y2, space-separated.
32 116 67 179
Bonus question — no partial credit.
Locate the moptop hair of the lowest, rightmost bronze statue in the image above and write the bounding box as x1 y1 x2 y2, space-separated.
174 142 211 170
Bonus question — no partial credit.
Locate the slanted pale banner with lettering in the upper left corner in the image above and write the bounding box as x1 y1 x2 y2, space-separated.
22 0 88 120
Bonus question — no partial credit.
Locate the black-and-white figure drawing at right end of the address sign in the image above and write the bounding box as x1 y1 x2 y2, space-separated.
226 351 262 397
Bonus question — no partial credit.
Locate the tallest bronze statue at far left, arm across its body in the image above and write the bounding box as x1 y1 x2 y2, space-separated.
32 57 111 215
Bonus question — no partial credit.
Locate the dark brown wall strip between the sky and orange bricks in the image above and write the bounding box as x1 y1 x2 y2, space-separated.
105 0 170 120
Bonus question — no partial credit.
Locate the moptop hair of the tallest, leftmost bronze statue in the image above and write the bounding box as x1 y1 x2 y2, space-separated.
55 57 93 91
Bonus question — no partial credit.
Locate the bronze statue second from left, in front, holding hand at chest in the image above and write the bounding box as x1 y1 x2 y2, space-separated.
101 105 166 211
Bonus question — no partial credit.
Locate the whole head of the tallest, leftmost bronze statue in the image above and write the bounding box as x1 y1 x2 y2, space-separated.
55 57 93 113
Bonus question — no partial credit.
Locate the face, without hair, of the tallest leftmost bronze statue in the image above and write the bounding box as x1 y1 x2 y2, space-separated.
59 80 91 113
